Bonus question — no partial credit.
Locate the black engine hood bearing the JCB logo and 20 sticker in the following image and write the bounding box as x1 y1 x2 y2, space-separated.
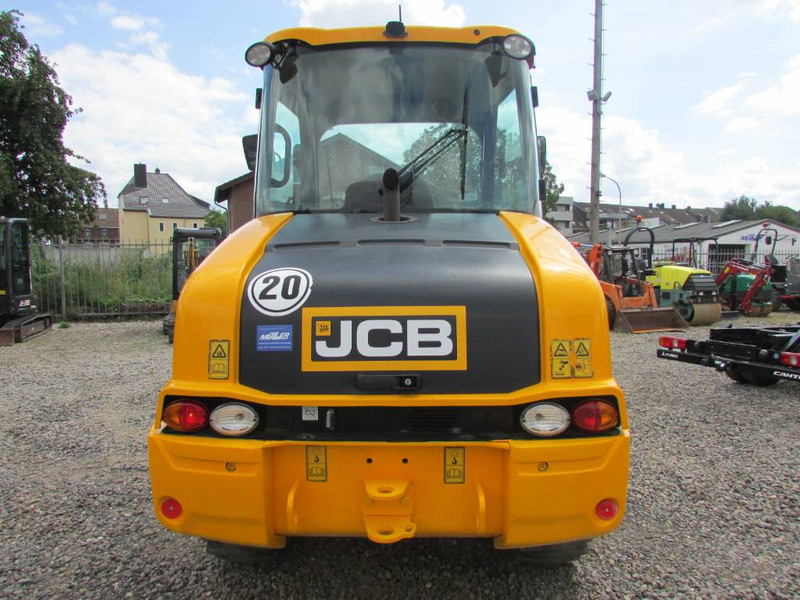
239 214 540 394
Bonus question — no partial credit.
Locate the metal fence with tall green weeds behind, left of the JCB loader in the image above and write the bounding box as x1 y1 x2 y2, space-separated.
31 243 172 319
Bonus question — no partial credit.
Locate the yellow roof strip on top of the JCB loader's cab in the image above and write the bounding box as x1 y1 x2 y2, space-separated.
265 25 519 46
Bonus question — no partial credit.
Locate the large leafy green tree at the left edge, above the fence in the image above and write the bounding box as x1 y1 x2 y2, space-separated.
0 10 106 237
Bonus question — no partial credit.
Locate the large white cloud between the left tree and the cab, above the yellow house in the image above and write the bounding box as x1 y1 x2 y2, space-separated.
53 44 252 203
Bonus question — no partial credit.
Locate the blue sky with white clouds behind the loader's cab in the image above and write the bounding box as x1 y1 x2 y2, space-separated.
6 0 800 210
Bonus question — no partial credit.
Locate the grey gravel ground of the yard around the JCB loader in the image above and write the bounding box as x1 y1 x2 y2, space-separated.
0 312 800 599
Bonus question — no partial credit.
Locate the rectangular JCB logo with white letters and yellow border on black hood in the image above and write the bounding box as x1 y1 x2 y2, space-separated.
303 306 467 371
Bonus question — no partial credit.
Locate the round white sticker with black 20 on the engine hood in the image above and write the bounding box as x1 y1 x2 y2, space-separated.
247 268 314 317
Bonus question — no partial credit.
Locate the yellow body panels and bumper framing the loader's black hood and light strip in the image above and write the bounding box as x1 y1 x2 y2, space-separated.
148 213 630 548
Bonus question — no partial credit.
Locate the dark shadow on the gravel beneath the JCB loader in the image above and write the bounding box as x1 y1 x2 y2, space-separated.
211 538 580 598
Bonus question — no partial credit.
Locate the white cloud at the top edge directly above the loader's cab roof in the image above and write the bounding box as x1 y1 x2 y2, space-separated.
291 0 466 27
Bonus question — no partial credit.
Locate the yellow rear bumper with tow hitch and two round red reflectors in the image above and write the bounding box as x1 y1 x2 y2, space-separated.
148 430 630 548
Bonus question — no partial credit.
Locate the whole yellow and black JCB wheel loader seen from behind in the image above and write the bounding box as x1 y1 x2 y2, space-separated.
148 17 630 563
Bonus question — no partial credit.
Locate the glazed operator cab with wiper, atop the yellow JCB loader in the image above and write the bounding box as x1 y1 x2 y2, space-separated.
248 23 544 216
